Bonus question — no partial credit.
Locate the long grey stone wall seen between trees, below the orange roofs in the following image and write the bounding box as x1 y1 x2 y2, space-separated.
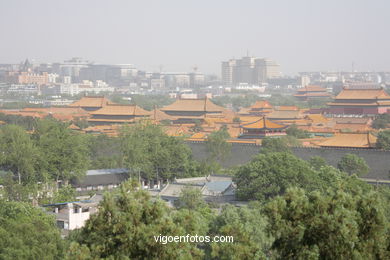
188 142 390 180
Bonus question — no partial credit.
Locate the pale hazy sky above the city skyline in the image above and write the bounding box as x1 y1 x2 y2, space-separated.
0 0 390 75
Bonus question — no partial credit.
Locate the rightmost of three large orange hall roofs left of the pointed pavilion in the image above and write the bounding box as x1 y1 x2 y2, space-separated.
161 98 225 112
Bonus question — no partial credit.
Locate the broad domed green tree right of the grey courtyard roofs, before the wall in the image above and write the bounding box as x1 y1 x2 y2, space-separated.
234 153 323 201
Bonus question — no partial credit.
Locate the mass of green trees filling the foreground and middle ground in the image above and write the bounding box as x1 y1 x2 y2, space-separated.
0 119 390 259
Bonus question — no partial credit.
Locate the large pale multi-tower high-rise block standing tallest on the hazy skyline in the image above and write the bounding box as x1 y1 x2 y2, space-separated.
221 57 280 86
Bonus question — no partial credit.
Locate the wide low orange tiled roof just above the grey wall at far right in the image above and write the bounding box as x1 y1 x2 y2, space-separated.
318 133 376 148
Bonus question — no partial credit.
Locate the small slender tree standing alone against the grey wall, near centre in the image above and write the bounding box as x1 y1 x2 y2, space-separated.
206 127 232 161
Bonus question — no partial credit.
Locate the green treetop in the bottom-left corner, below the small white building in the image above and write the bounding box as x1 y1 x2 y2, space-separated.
0 200 63 260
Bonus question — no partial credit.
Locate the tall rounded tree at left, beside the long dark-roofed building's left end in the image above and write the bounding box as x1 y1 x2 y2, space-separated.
33 119 89 181
